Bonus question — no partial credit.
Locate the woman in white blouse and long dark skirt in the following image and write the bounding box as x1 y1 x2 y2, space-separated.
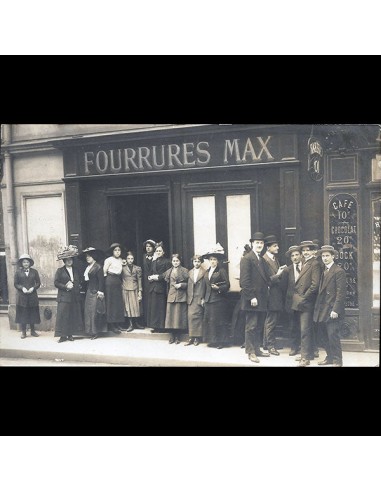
103 243 125 335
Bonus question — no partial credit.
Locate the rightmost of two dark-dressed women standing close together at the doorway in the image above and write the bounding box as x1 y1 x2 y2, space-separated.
147 242 171 333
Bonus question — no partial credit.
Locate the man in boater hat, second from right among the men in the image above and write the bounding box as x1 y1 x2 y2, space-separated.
291 241 321 367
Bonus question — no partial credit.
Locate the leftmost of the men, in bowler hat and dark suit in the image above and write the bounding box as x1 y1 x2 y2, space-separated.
240 232 271 362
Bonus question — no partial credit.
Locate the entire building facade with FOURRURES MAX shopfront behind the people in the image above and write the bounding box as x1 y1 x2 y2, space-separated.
2 125 381 350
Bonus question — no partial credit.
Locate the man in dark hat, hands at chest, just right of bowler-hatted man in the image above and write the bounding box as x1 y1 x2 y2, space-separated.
263 236 283 355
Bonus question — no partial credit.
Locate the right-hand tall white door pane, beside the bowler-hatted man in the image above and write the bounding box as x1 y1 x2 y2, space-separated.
226 195 251 292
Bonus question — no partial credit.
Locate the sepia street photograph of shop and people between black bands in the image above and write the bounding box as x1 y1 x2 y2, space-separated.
0 123 381 371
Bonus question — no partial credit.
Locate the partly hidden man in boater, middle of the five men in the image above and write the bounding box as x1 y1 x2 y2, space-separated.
282 245 302 356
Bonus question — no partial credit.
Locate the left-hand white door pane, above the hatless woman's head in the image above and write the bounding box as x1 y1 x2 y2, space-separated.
193 196 217 260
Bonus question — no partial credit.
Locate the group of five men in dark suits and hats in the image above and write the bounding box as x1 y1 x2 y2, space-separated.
240 232 346 367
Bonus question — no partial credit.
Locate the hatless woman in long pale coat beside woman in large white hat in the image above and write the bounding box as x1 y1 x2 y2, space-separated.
185 255 206 345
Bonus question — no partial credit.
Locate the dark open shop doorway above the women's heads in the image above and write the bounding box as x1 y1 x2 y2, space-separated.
110 193 171 265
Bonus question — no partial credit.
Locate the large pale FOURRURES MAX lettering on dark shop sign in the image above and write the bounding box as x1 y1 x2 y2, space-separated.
81 136 279 176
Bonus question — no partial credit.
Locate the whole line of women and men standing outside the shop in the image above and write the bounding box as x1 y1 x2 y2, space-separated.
14 232 346 367
